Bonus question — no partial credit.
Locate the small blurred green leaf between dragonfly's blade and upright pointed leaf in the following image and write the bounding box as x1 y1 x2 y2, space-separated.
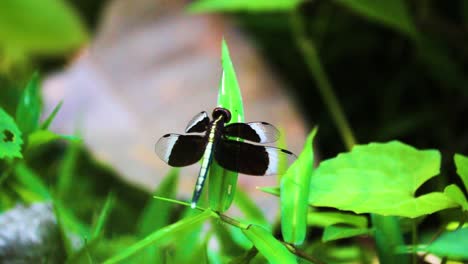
234 189 270 228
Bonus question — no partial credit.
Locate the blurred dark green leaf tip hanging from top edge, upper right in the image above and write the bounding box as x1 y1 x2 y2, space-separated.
335 0 417 37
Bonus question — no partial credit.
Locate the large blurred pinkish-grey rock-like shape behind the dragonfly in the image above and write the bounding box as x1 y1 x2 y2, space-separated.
44 0 305 210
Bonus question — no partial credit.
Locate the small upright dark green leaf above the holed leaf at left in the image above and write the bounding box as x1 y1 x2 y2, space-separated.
15 73 41 136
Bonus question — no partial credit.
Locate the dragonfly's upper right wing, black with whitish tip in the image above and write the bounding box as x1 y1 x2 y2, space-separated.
224 122 279 143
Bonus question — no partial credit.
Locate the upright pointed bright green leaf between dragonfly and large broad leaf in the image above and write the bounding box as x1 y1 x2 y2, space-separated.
280 128 317 245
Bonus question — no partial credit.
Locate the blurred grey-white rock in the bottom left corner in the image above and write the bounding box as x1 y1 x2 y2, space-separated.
0 203 65 263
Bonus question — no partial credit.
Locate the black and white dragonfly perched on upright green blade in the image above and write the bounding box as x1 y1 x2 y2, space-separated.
155 107 296 208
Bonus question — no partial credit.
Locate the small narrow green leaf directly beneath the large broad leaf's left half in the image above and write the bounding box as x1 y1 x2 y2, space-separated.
307 212 367 228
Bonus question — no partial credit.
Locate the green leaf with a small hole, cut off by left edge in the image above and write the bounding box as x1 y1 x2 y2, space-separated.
0 107 23 159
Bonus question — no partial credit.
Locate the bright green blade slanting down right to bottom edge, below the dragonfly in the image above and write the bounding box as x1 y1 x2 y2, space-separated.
242 225 297 264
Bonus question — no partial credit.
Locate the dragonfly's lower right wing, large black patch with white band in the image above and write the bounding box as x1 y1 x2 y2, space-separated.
214 139 296 176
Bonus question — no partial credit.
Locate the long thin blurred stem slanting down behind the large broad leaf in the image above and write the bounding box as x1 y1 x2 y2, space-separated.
291 13 356 150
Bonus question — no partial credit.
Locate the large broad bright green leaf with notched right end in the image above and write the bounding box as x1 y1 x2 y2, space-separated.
309 141 456 218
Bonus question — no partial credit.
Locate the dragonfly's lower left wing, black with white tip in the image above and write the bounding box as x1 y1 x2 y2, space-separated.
155 134 207 167
